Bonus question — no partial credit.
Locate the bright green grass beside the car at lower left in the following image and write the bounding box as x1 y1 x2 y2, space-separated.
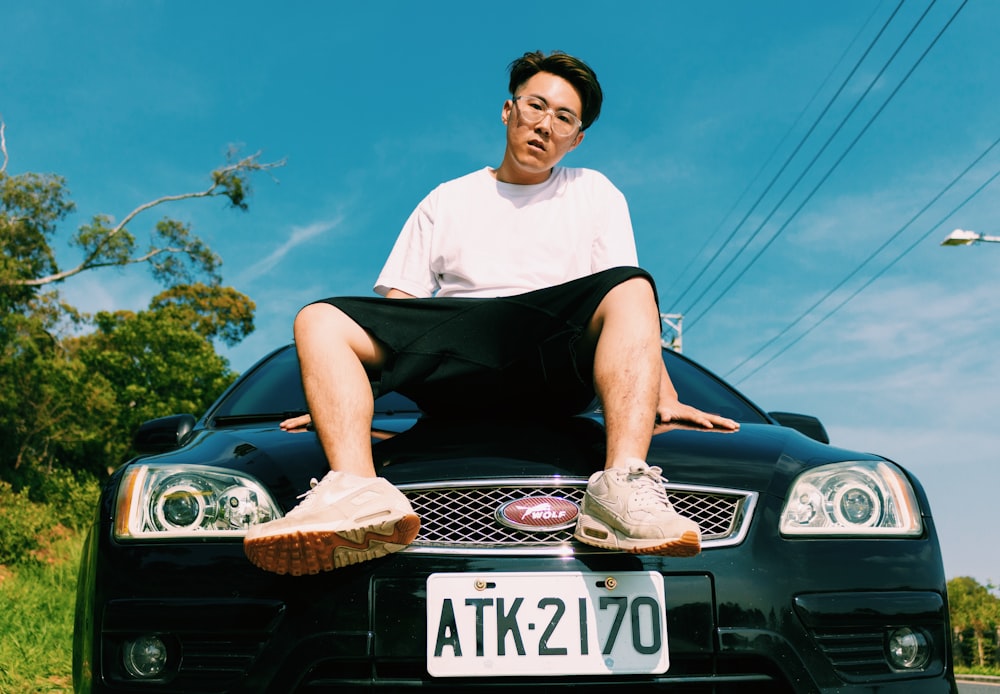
0 526 83 694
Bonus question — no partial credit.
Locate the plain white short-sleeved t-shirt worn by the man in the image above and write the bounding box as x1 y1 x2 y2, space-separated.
375 167 638 297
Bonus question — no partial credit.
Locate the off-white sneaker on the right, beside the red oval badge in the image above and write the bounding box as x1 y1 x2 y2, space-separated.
574 460 701 557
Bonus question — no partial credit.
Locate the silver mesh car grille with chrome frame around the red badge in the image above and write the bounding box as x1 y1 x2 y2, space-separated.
400 478 757 554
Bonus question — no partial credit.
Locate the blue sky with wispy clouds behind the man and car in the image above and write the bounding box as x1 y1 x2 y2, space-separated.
0 0 1000 582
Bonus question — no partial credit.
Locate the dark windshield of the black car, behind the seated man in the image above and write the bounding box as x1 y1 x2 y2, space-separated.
212 345 767 422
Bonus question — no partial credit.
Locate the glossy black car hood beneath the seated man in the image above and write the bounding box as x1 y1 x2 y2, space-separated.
139 417 877 508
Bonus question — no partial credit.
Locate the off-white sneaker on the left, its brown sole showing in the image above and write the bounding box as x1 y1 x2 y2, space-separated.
243 471 420 576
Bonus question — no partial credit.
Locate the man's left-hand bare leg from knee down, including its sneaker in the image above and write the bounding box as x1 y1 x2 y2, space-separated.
243 304 420 576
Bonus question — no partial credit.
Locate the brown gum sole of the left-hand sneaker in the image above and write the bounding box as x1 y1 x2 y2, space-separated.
243 514 420 576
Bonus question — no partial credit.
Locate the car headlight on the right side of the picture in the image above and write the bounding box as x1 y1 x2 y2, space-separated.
781 460 923 537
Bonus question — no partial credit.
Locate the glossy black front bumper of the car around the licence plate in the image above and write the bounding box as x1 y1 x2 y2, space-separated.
75 528 956 694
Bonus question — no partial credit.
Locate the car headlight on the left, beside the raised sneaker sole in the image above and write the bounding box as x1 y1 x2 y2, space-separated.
115 465 282 540
